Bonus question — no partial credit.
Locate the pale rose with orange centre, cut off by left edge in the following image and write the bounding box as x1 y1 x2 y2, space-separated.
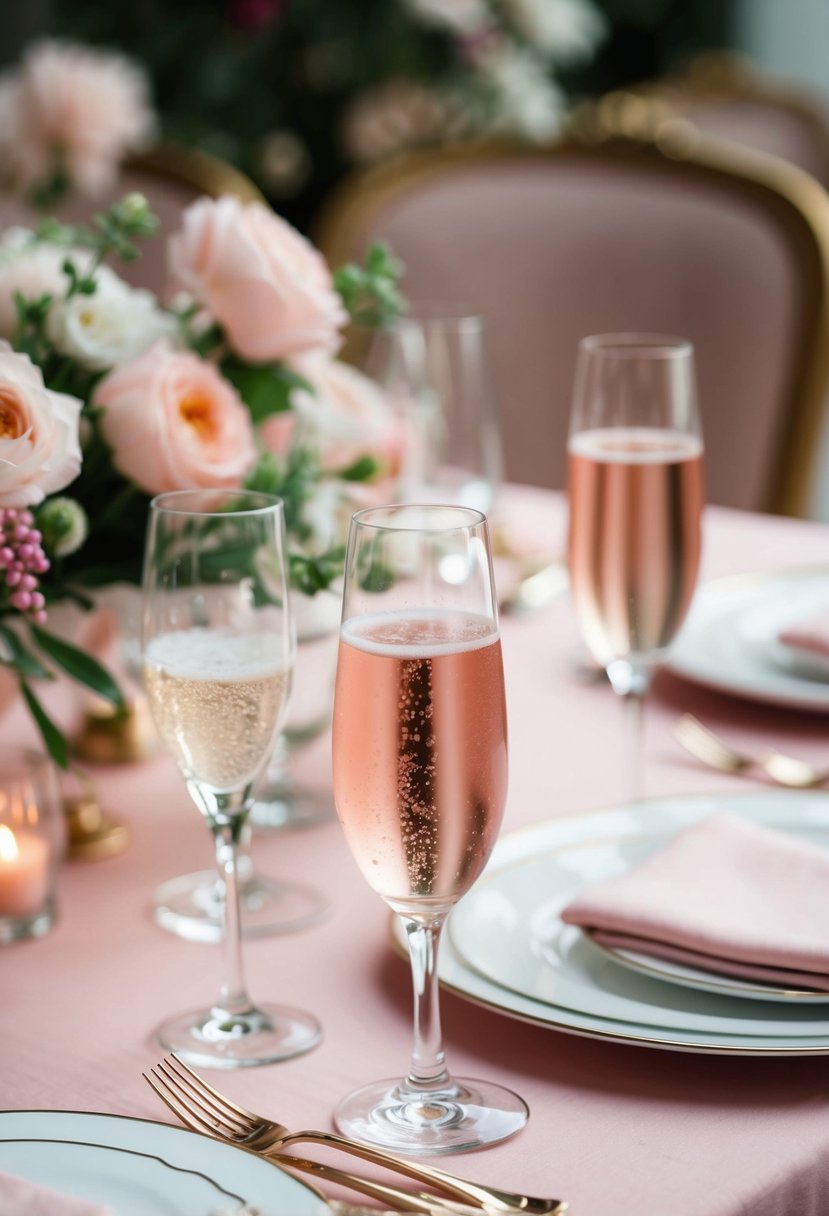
0 343 81 507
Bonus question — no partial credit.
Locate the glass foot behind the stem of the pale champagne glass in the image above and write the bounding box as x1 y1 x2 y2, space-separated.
156 869 329 941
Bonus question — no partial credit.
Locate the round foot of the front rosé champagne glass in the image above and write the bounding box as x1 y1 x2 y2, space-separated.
334 1077 530 1155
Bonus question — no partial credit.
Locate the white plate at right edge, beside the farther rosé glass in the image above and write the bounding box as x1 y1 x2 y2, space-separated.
666 568 829 713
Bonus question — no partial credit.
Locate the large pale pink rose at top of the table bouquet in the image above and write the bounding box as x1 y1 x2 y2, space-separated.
169 196 346 362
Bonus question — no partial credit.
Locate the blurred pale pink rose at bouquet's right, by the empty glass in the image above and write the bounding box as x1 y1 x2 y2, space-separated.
284 355 404 479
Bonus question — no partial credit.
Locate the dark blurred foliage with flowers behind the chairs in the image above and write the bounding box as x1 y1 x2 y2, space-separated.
0 0 732 231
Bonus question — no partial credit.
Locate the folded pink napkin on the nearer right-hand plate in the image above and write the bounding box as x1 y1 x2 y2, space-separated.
562 812 829 991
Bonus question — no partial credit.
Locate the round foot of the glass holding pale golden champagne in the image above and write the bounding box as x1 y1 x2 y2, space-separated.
154 1004 322 1068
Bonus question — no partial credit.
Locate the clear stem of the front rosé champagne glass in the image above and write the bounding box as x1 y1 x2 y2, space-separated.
405 912 450 1091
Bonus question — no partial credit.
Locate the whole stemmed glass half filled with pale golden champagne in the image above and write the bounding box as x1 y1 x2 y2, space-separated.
142 490 321 1068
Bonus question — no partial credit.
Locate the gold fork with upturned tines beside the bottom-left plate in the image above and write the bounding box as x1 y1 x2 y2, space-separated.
143 1054 566 1216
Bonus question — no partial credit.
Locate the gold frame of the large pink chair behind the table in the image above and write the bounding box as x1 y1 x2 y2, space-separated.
312 125 829 517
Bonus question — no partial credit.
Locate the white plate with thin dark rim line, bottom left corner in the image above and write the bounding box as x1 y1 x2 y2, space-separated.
0 1110 328 1216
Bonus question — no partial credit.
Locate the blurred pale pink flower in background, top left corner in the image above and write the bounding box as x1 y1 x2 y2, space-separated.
0 40 156 195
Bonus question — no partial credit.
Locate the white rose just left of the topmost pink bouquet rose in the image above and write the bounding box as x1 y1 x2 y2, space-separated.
46 266 177 371
